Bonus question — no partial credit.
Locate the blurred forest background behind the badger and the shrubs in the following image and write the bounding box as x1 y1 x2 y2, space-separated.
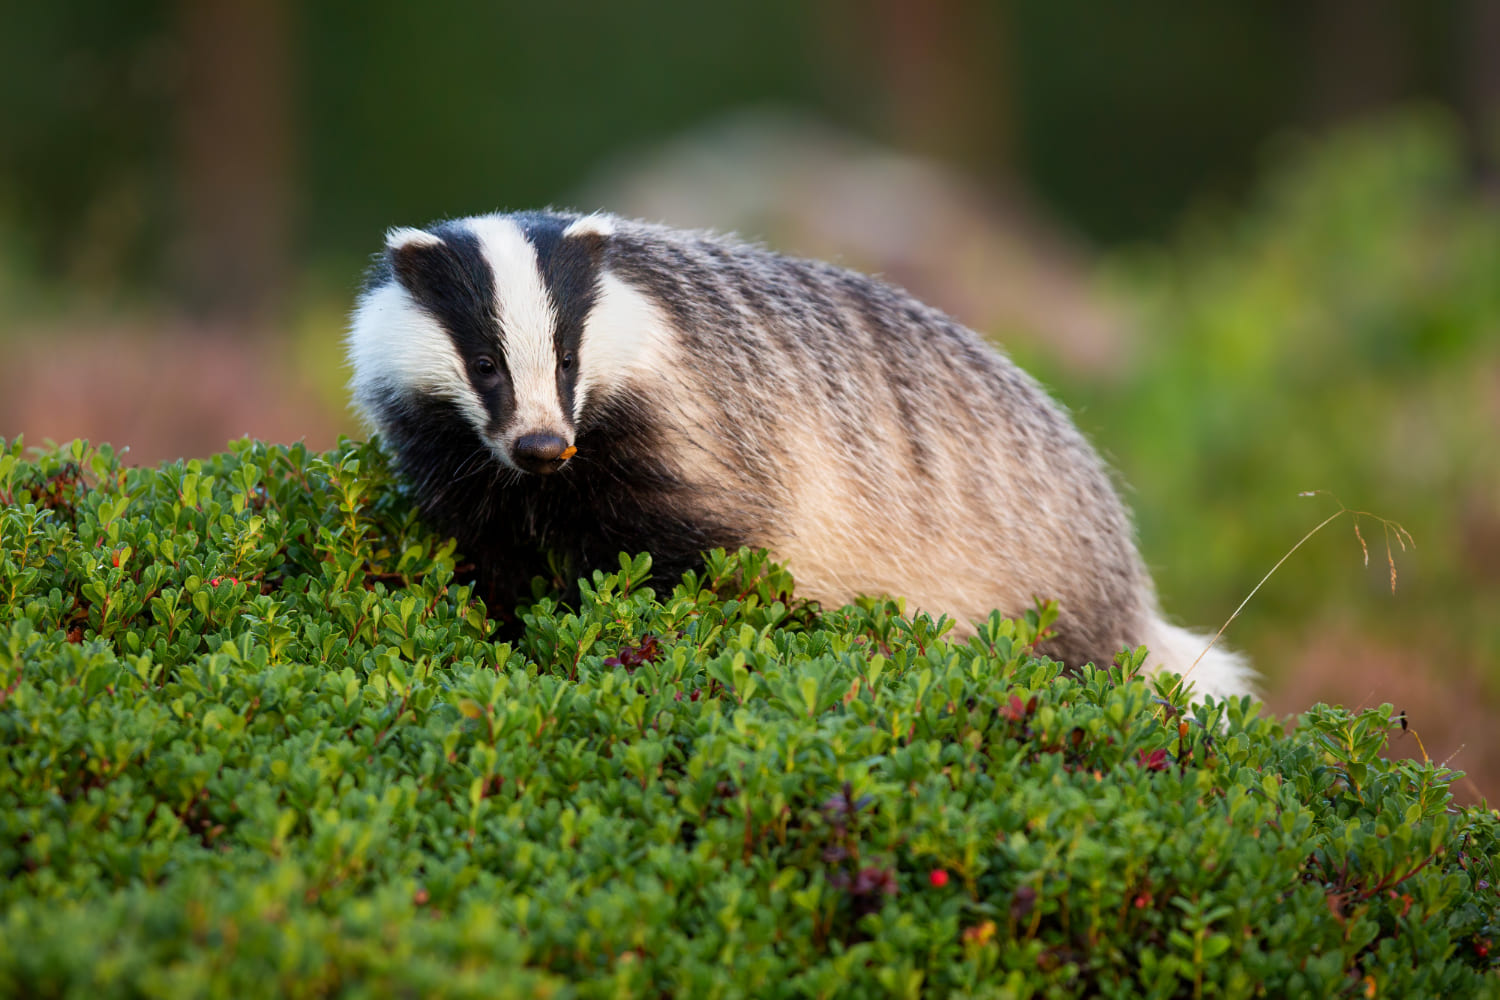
0 0 1500 802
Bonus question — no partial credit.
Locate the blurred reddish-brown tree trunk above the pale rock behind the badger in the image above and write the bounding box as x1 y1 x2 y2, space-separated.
827 0 1014 172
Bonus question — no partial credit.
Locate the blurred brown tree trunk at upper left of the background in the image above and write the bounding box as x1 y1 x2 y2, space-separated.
173 0 293 331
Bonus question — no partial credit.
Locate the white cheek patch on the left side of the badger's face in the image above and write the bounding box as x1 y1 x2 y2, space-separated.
348 280 488 427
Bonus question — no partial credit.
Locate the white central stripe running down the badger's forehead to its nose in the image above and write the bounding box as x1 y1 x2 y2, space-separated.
467 216 564 433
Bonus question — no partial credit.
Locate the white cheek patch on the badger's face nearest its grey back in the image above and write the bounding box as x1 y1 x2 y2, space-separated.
573 269 668 421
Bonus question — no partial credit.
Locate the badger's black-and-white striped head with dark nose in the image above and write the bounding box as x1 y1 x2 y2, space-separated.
348 213 653 474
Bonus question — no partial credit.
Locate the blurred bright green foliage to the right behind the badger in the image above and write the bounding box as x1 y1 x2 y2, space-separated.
1049 109 1500 683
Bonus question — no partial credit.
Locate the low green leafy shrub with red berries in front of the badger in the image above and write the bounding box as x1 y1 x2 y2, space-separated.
0 442 1500 999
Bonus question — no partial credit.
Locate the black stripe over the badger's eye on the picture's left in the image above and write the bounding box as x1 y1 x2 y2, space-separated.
386 222 515 432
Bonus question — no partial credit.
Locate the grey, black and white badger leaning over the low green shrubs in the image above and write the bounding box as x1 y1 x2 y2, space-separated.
347 210 1251 697
